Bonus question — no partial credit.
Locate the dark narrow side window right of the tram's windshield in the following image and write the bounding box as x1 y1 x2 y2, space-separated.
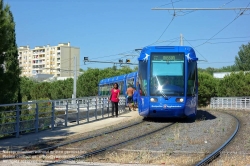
187 62 197 96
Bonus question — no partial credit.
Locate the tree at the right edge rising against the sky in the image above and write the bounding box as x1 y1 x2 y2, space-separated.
235 42 250 71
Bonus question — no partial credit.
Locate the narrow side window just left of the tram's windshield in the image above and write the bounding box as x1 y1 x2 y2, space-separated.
138 61 148 96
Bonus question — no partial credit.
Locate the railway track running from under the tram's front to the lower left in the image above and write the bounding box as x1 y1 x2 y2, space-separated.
4 118 176 164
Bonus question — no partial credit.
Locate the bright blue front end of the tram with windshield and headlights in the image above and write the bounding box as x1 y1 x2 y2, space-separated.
138 46 198 117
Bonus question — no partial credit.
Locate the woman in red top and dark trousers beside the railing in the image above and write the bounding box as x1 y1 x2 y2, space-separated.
110 83 120 117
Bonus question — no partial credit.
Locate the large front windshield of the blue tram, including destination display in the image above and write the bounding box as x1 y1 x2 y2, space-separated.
150 53 184 97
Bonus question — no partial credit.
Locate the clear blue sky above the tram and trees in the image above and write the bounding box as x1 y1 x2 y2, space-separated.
3 0 250 70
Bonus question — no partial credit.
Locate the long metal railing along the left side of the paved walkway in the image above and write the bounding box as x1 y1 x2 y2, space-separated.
0 96 126 137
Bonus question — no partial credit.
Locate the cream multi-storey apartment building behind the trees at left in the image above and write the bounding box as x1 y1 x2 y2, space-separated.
18 43 80 77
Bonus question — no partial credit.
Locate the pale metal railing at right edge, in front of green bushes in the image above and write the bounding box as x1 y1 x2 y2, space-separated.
210 97 250 109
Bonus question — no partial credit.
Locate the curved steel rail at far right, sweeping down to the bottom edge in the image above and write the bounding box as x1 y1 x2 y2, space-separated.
196 113 240 166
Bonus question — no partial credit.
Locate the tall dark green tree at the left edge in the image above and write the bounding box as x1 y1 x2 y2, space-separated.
0 0 21 104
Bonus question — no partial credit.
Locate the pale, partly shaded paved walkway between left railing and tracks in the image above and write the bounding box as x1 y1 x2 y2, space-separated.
0 111 139 151
